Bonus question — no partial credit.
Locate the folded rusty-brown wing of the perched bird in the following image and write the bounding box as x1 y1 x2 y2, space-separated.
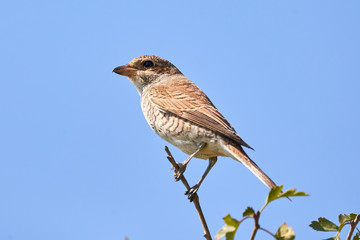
149 75 253 149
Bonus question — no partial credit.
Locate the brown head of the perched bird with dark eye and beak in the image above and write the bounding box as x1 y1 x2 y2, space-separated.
113 55 182 95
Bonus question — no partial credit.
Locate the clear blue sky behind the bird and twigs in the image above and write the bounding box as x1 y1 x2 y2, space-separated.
0 0 360 240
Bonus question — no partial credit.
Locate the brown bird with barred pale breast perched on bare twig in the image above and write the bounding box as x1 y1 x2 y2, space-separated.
113 55 276 201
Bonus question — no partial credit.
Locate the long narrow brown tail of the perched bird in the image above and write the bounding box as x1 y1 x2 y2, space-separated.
224 144 276 188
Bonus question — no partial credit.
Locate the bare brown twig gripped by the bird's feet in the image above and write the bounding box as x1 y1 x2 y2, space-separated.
165 146 211 240
